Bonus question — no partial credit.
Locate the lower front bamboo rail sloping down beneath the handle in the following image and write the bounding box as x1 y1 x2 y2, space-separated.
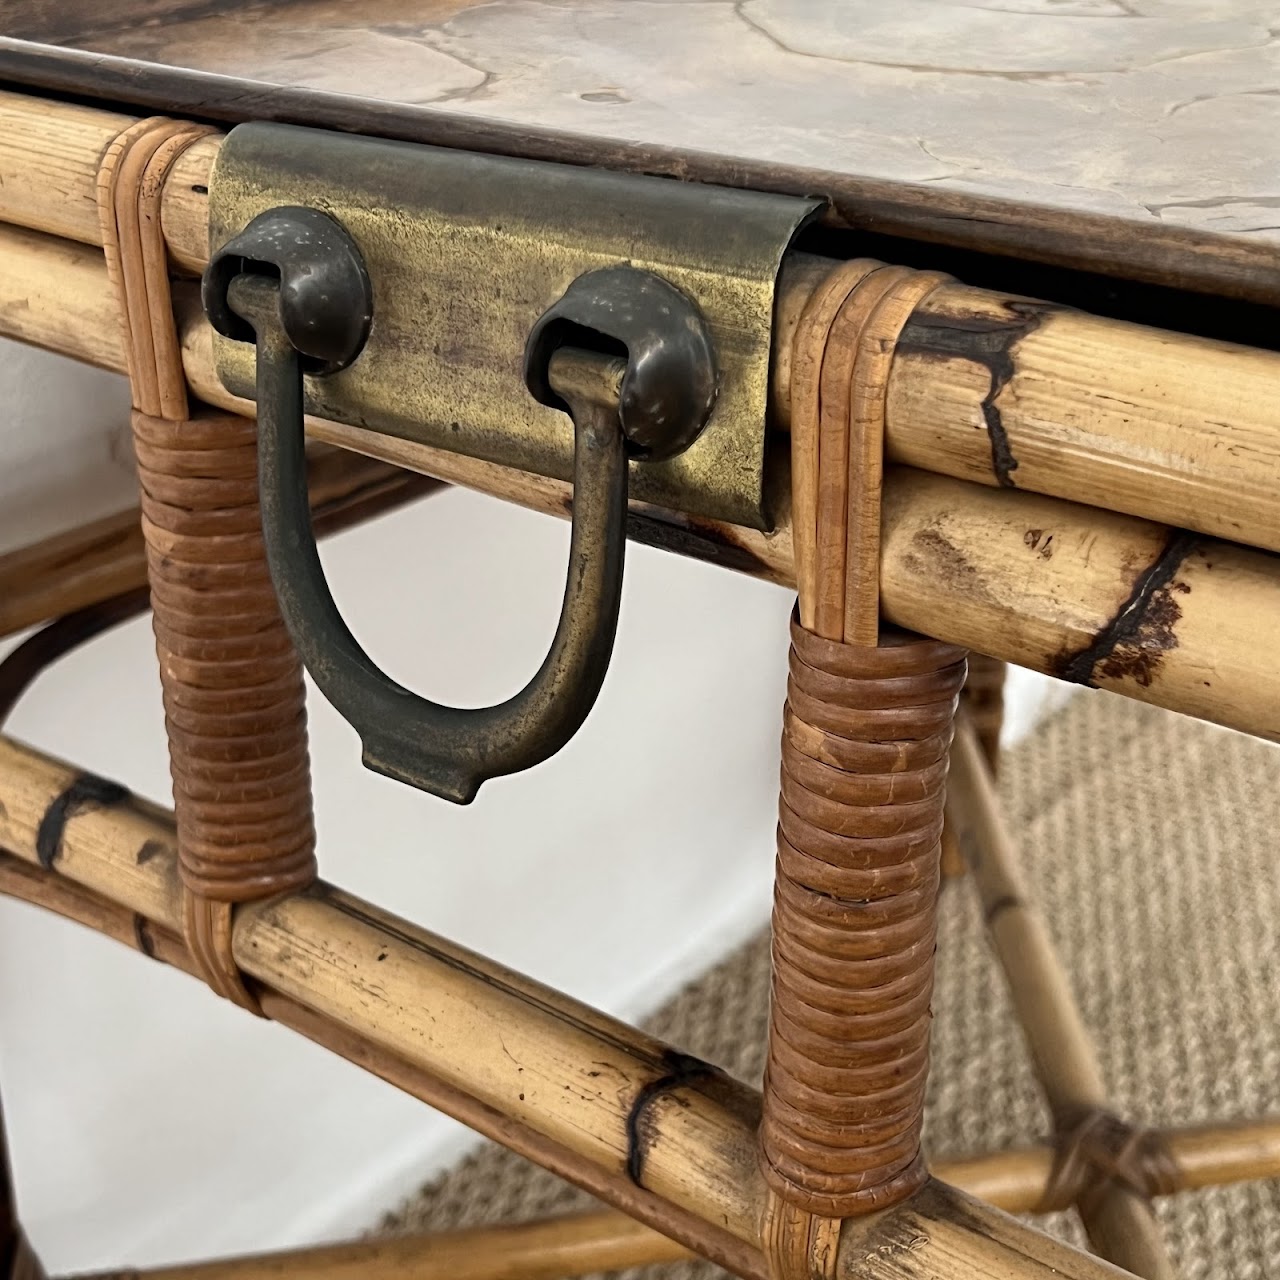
0 739 1120 1280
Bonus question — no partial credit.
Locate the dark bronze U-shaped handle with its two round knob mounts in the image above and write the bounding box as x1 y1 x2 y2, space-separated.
206 210 716 804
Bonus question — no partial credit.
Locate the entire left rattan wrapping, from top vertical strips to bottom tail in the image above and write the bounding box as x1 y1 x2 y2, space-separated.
97 118 316 1011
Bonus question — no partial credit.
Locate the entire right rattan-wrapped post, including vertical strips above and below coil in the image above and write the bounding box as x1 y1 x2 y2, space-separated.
760 261 965 1280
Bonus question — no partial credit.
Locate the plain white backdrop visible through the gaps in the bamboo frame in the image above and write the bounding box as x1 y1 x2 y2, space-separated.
0 353 1070 1272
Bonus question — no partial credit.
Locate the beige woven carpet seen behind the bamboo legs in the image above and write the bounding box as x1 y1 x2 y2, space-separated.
387 694 1280 1280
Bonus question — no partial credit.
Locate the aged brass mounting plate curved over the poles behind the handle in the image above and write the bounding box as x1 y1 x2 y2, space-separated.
209 124 819 529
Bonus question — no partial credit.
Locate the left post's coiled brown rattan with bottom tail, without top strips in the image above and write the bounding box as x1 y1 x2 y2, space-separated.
133 412 316 1009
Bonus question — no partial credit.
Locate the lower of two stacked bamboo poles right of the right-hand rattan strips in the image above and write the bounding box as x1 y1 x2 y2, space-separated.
881 467 1280 740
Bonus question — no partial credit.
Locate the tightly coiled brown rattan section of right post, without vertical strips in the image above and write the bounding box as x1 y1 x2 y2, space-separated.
762 620 965 1219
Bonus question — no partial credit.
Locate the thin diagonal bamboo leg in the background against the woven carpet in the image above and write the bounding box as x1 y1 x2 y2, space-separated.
947 717 1175 1280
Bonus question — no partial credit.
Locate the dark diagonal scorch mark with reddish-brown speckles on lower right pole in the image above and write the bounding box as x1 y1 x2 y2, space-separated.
1052 529 1201 689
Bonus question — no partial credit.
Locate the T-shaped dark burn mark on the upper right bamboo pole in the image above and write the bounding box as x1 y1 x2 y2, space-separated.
897 298 1062 489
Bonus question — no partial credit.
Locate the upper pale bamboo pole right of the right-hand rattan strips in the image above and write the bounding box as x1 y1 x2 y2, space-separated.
886 284 1280 550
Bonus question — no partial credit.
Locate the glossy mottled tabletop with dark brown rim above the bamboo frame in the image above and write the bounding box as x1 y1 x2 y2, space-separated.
0 0 1280 301
